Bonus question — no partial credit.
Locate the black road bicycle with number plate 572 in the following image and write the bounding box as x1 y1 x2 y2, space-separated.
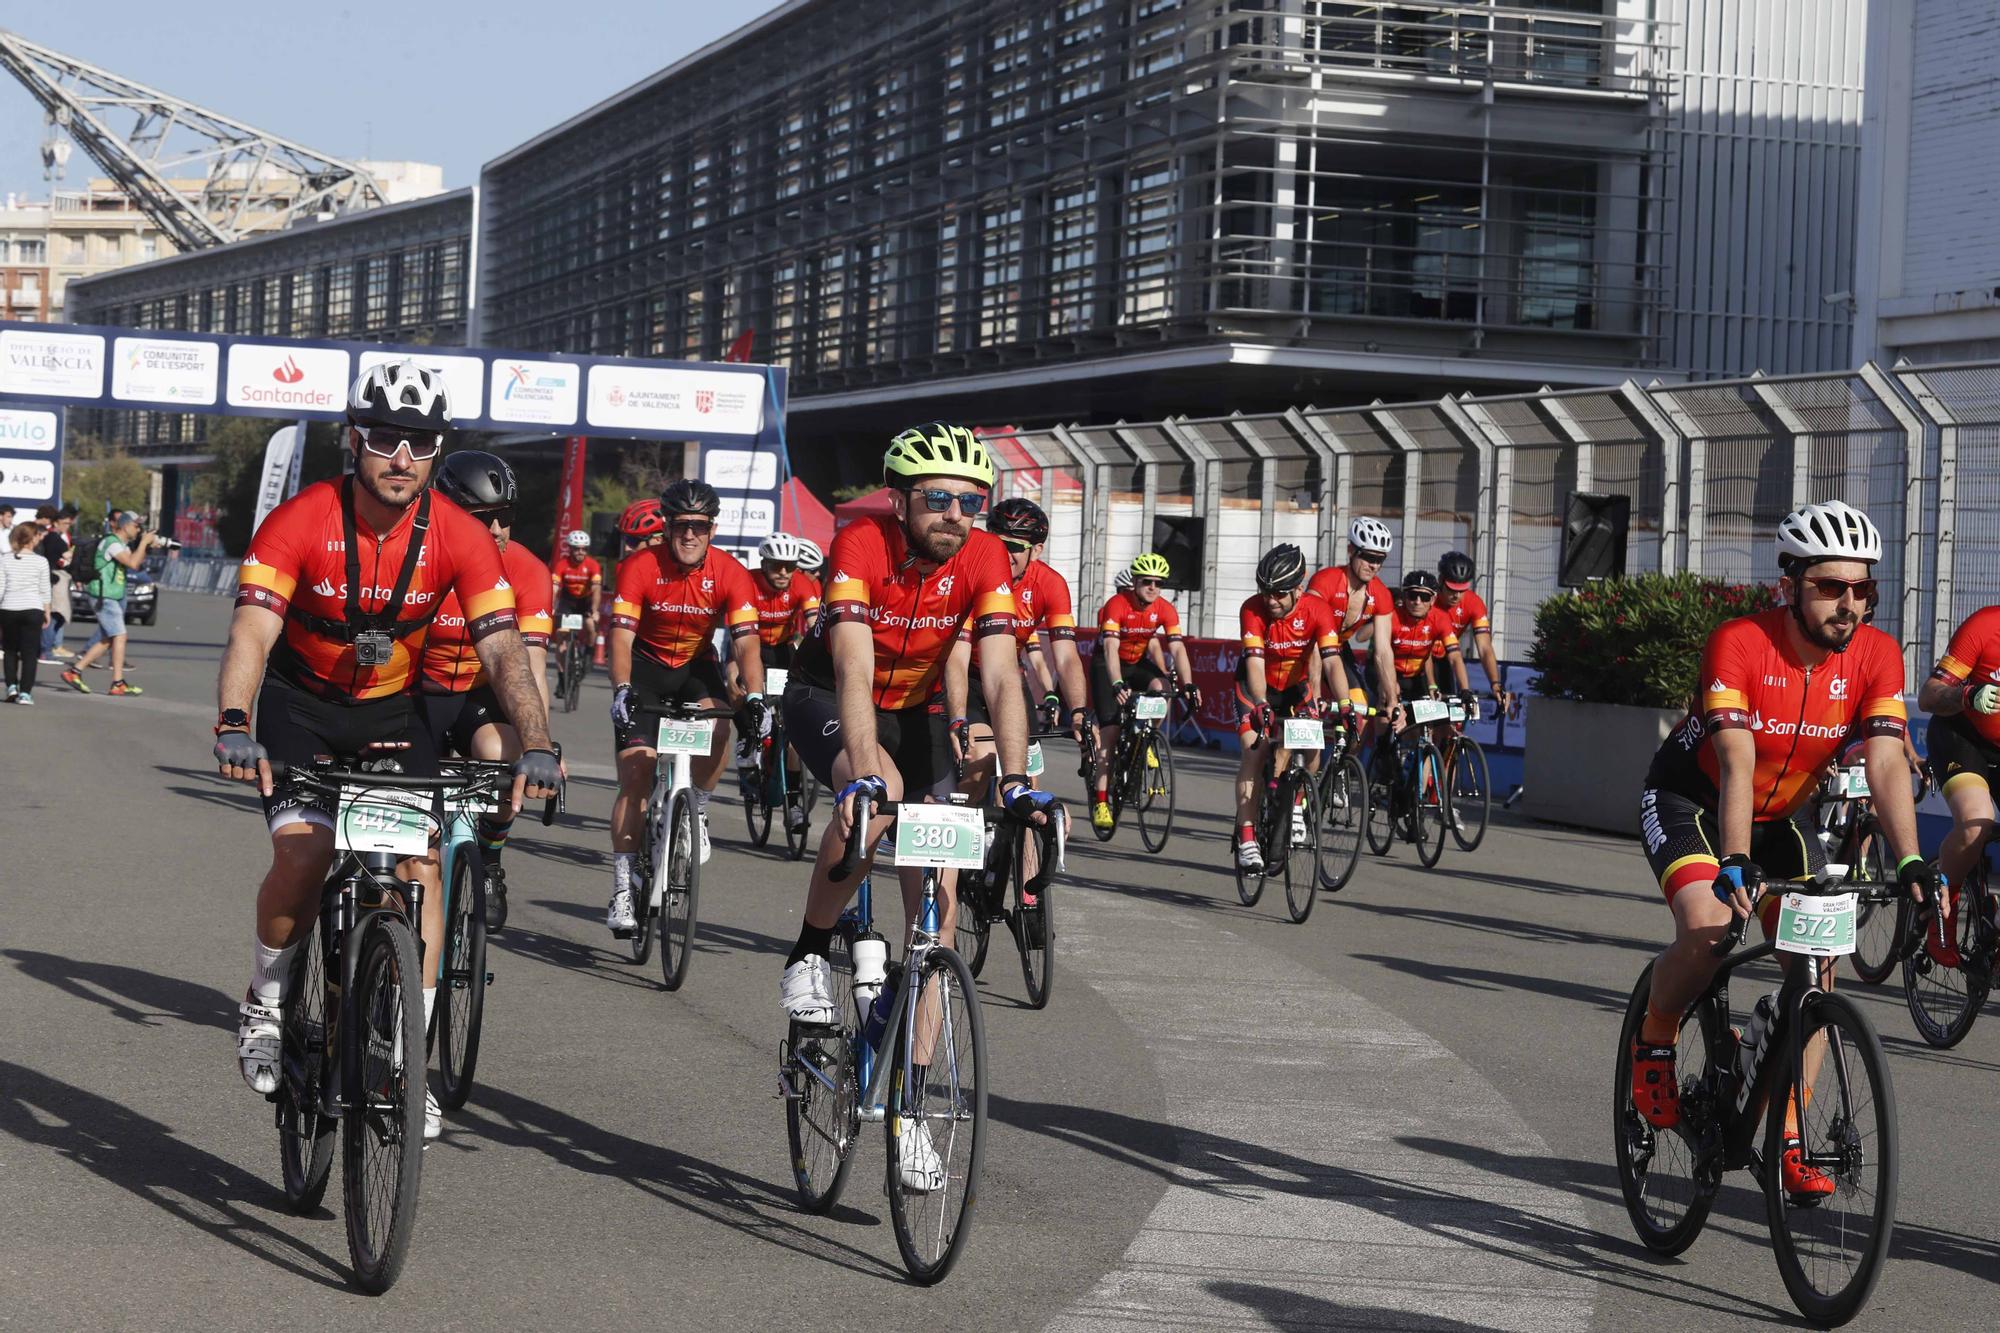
1612 877 1896 1325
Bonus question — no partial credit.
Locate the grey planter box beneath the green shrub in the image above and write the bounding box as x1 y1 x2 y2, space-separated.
1522 699 1684 833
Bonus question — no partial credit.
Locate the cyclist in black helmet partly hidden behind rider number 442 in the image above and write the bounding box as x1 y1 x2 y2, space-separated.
422 450 554 929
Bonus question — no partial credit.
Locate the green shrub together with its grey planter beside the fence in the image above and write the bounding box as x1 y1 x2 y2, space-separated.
1522 574 1774 833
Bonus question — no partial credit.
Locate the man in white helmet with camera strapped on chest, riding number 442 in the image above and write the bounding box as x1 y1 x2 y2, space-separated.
214 360 562 1137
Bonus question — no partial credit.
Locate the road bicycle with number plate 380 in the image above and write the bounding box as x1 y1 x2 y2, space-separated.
778 793 992 1285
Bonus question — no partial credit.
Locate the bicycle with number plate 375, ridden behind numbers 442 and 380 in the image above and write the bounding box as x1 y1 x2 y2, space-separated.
628 703 734 991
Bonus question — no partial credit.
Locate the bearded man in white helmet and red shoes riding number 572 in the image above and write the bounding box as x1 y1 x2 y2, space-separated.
1632 500 1936 1199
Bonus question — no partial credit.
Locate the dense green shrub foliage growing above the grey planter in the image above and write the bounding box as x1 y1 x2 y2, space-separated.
1528 574 1776 709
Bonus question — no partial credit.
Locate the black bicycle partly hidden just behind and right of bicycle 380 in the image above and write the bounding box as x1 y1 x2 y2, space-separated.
956 731 1064 1009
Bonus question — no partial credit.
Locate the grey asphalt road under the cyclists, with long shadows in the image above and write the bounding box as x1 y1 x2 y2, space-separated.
0 592 2000 1329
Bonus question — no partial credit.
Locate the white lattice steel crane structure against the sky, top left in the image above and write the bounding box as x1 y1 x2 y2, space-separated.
0 30 386 250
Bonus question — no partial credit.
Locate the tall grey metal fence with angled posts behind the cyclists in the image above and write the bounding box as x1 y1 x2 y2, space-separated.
984 362 2000 687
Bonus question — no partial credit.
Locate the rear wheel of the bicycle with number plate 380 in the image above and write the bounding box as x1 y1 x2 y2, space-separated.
784 929 862 1213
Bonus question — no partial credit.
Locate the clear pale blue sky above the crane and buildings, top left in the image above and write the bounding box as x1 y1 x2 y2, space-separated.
0 0 774 198
